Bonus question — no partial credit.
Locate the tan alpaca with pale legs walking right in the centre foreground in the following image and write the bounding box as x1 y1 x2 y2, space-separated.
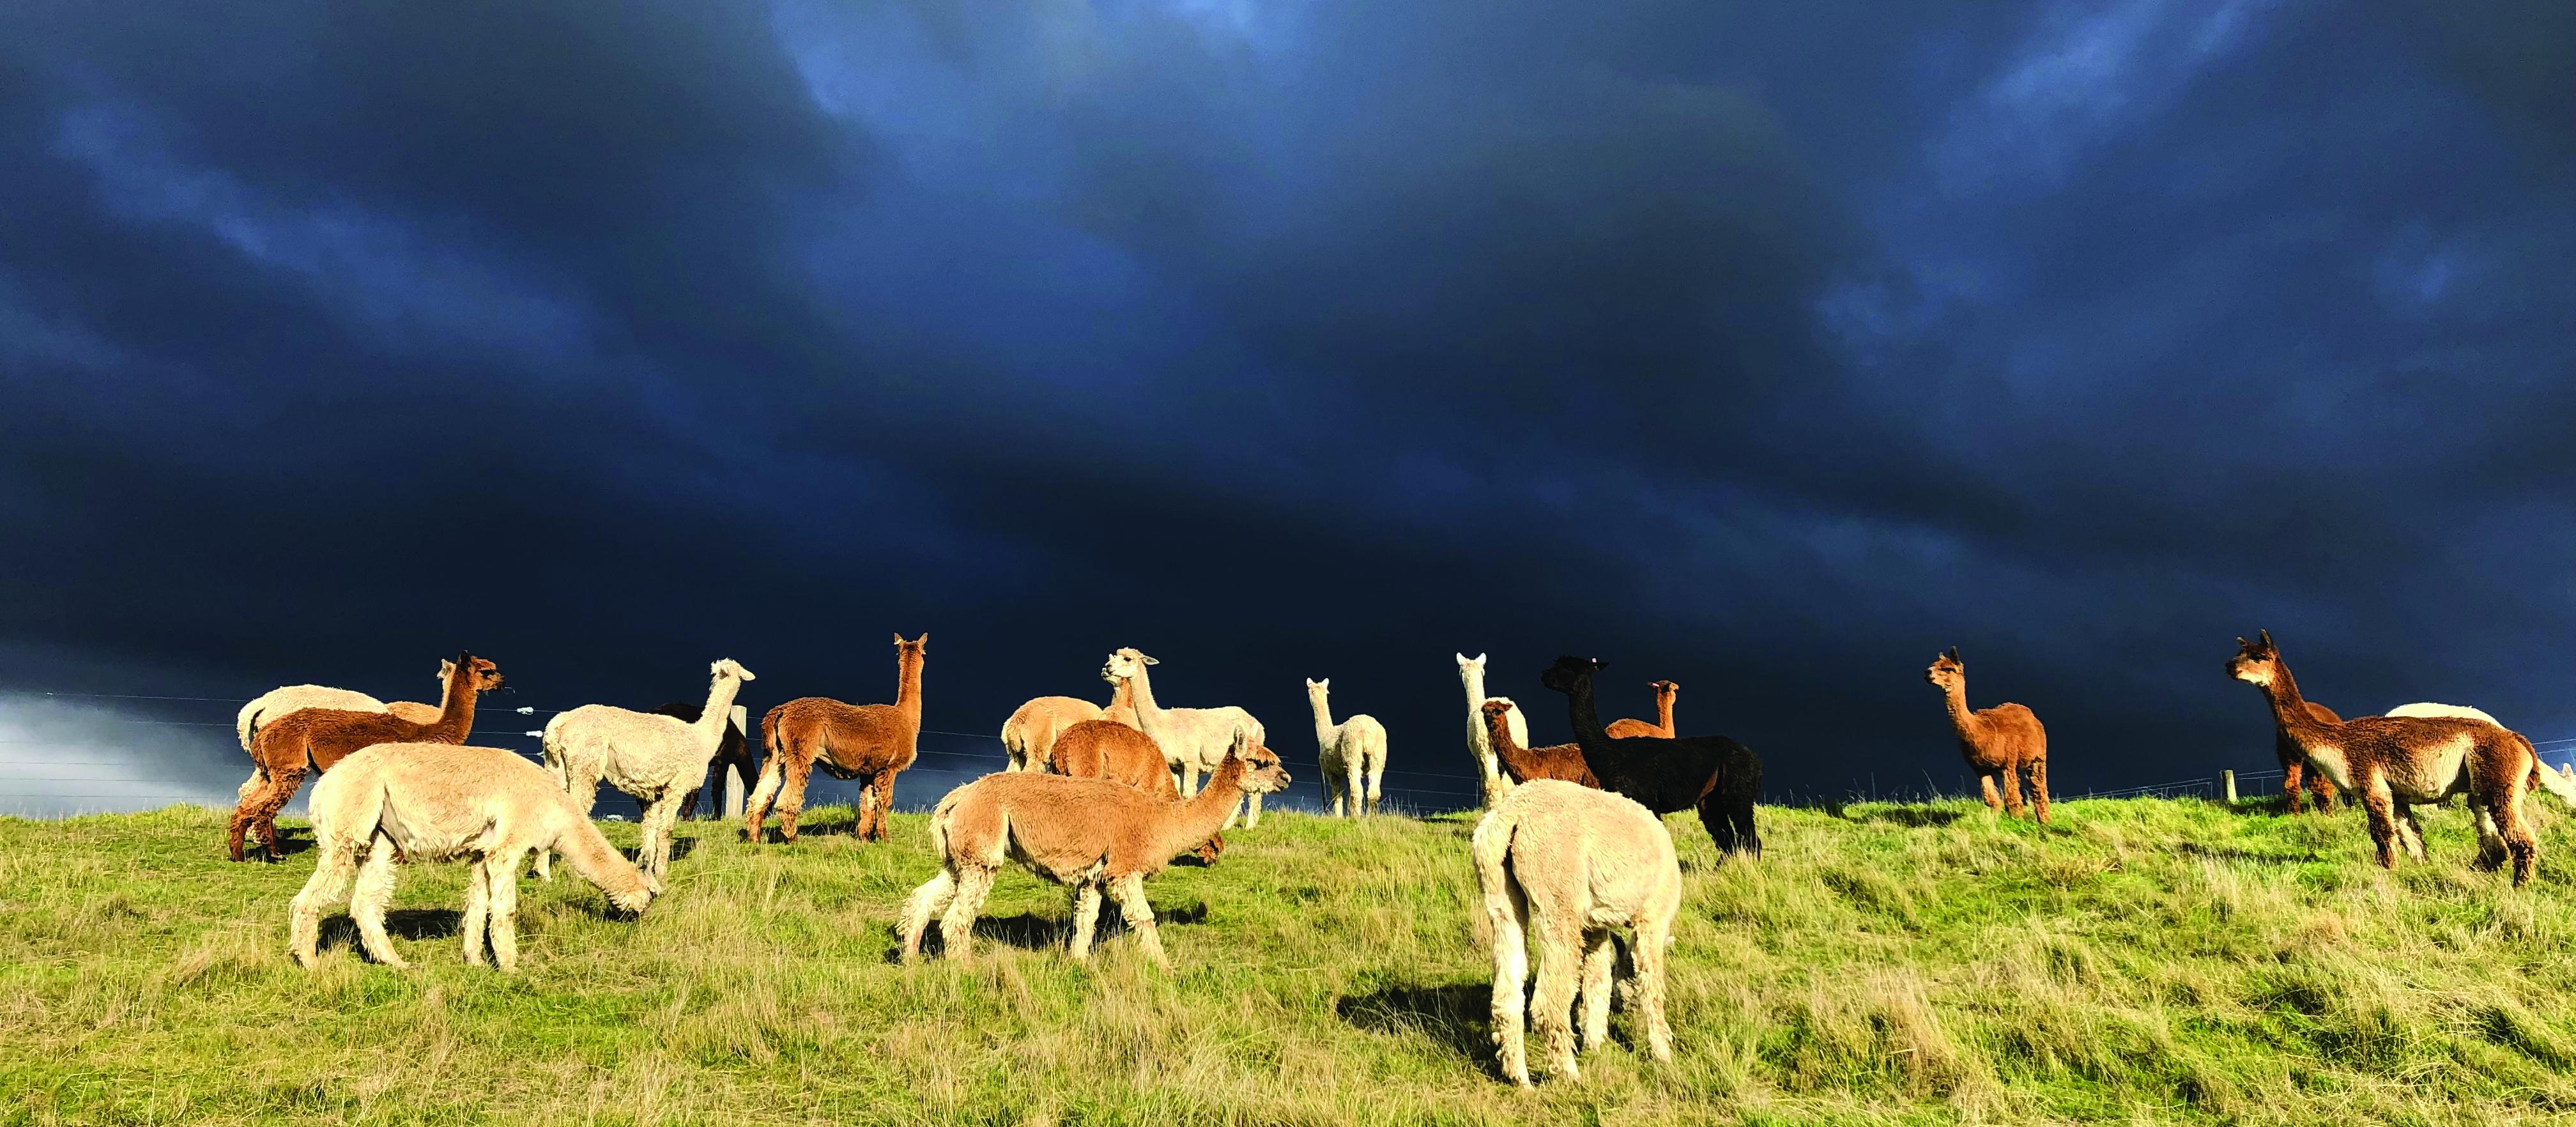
904 735 1288 967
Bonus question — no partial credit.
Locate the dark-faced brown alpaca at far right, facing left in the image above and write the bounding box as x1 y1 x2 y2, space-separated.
2228 631 2566 887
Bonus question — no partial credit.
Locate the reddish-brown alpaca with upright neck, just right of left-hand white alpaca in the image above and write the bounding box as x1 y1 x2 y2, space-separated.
742 633 930 841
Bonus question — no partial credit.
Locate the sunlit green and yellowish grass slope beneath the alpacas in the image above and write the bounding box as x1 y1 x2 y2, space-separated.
0 801 2576 1124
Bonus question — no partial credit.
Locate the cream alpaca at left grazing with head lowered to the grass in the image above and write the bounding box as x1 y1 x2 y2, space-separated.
286 744 659 970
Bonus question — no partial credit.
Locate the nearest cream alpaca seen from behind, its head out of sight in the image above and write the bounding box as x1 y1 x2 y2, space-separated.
1471 779 1682 1089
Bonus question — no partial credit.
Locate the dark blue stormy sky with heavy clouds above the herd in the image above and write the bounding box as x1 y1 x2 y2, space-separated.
0 0 2576 813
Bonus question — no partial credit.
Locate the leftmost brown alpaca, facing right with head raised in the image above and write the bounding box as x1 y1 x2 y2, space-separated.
227 654 500 862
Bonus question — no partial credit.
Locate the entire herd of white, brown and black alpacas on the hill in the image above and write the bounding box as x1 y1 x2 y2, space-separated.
227 633 2576 1086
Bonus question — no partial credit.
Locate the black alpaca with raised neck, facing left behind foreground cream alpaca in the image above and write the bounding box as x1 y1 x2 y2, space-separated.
1538 656 1762 857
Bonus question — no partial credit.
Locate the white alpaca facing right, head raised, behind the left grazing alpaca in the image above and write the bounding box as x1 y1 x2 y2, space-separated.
536 659 757 882
